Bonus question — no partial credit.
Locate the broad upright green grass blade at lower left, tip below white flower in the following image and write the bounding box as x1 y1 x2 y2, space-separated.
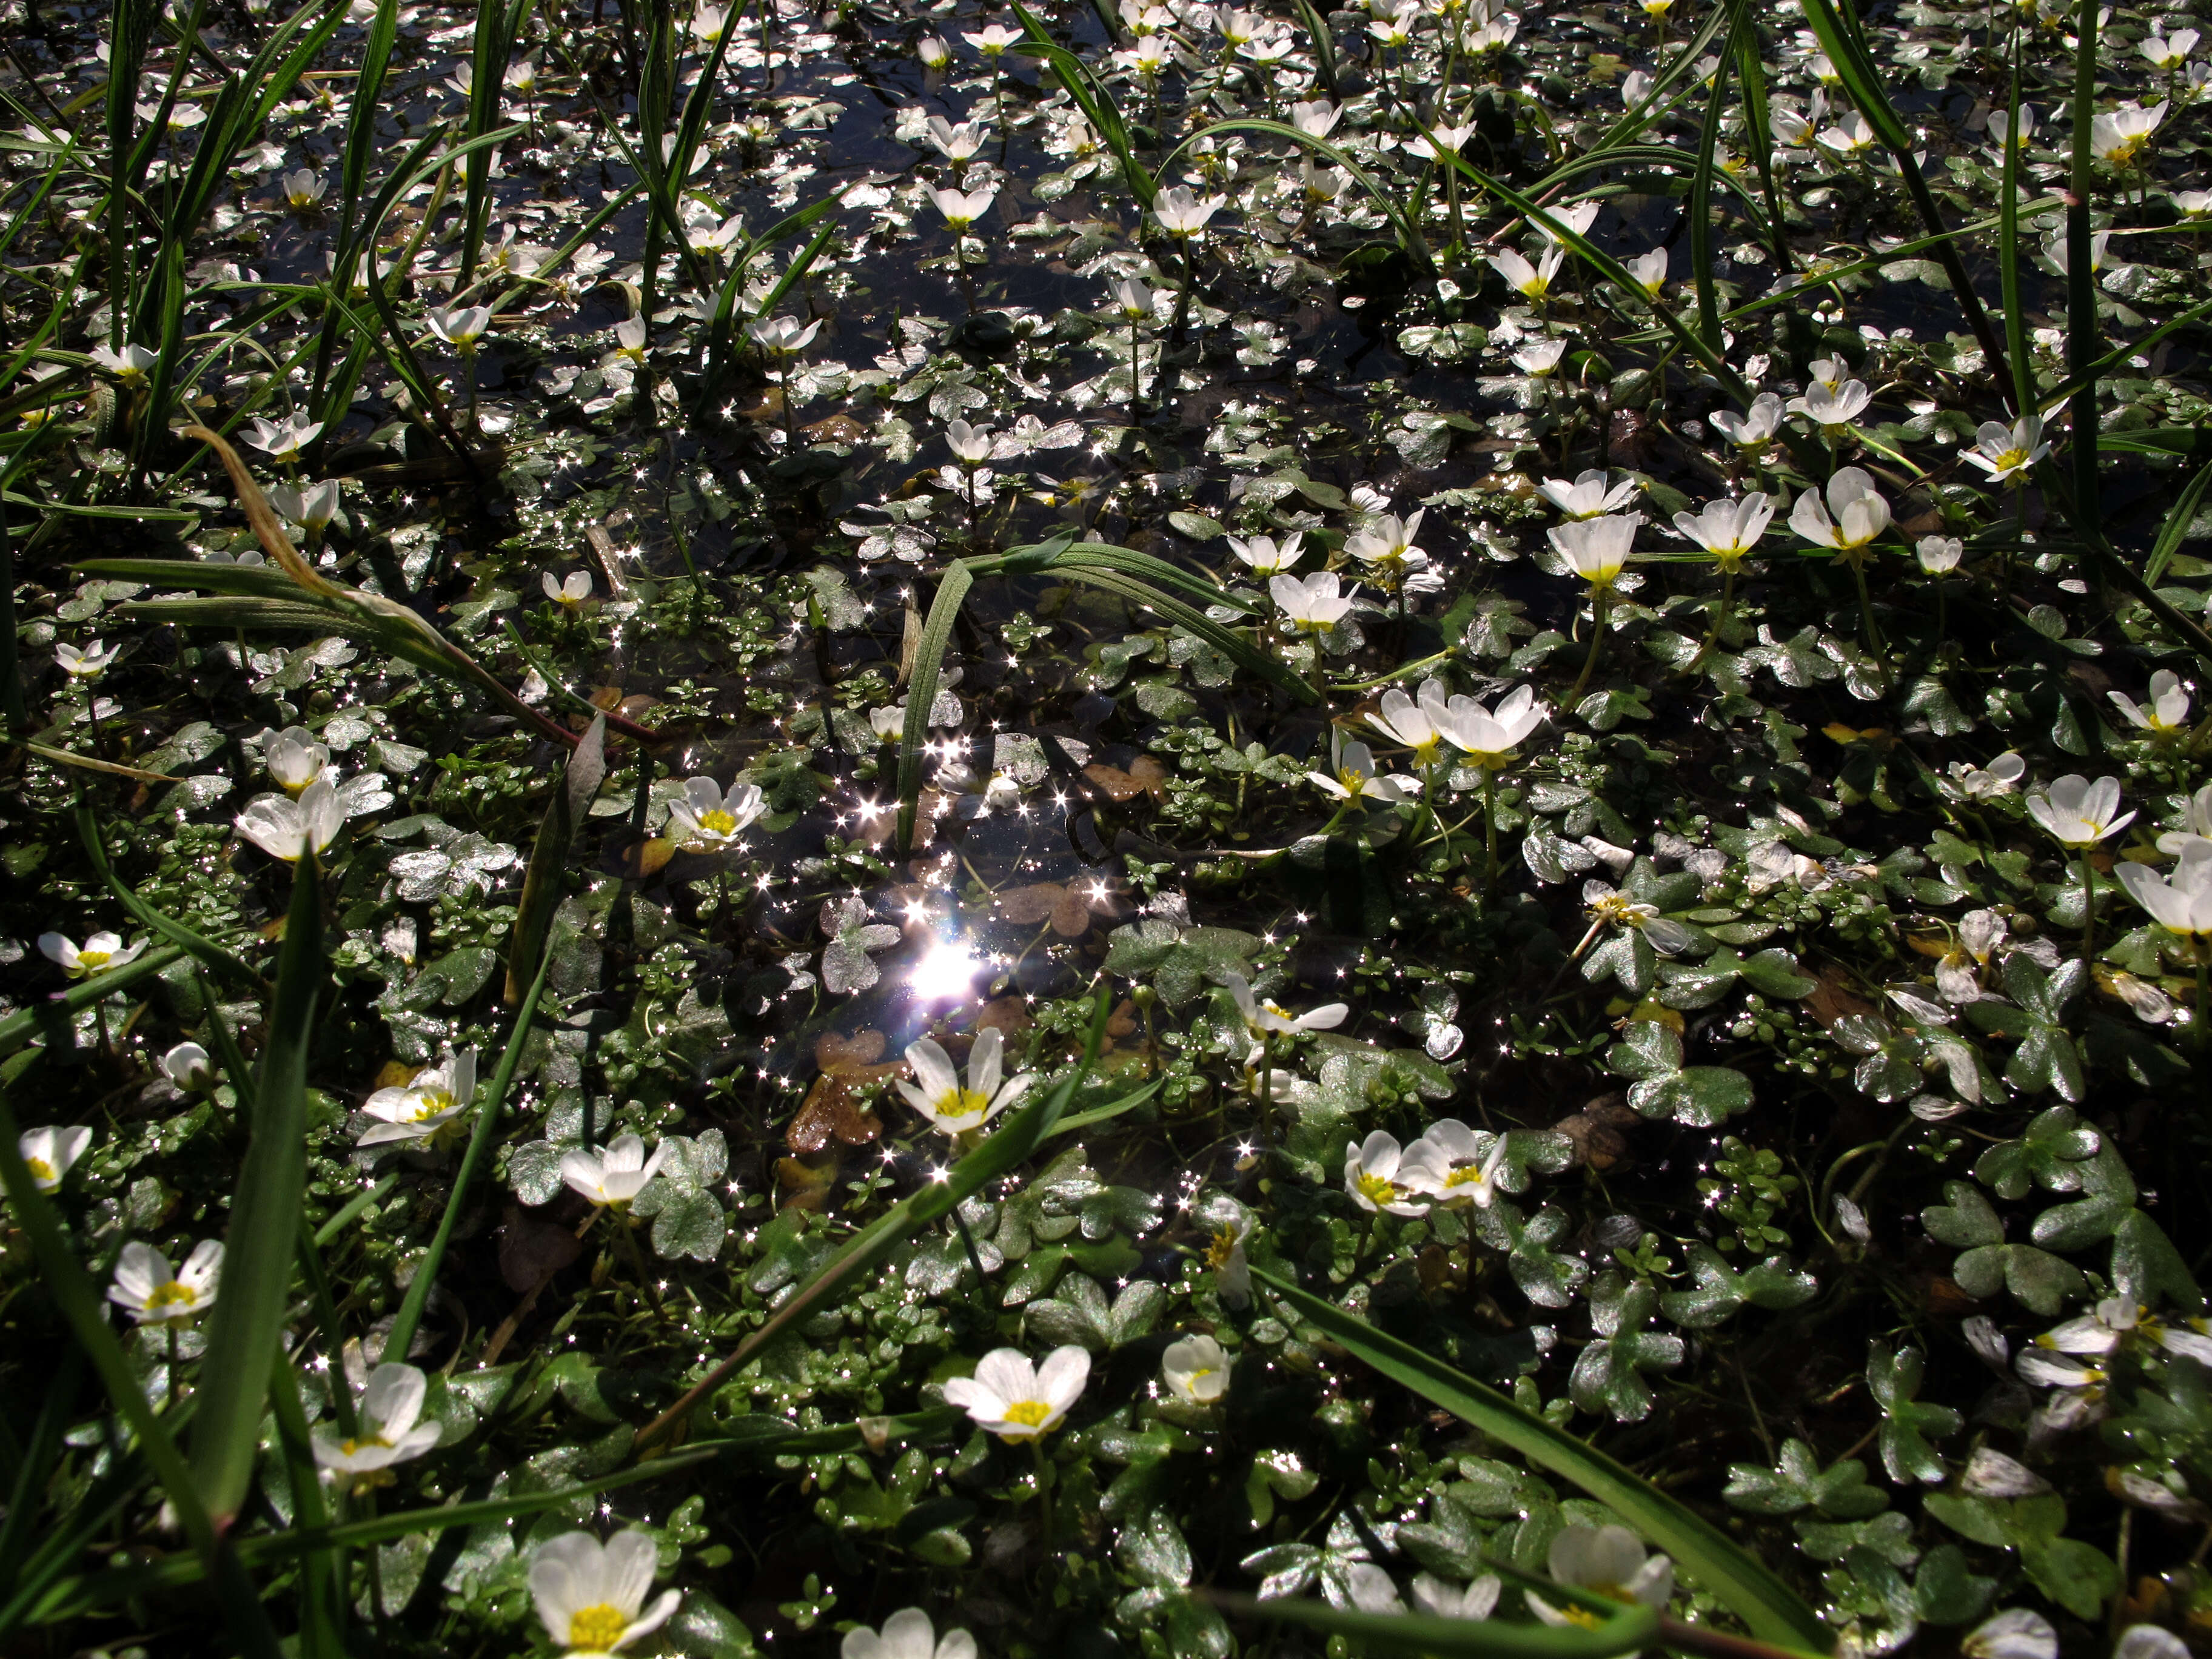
192 856 325 1526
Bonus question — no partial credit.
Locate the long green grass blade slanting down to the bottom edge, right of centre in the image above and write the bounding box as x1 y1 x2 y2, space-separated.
1252 1267 1834 1652
